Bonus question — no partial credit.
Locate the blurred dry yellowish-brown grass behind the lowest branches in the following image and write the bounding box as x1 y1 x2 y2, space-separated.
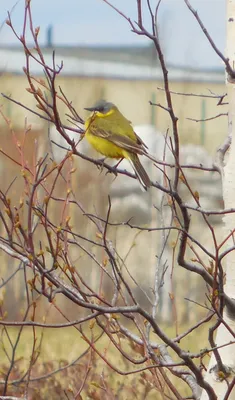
0 314 211 400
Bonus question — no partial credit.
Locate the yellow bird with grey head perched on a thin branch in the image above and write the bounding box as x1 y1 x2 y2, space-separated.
85 100 151 190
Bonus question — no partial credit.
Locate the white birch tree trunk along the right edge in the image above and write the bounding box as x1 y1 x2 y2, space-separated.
201 0 235 400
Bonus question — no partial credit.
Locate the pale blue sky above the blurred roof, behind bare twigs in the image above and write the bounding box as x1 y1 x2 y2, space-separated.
0 0 226 68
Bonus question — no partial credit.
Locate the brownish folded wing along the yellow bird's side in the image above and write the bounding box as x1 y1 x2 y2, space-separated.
89 126 146 155
